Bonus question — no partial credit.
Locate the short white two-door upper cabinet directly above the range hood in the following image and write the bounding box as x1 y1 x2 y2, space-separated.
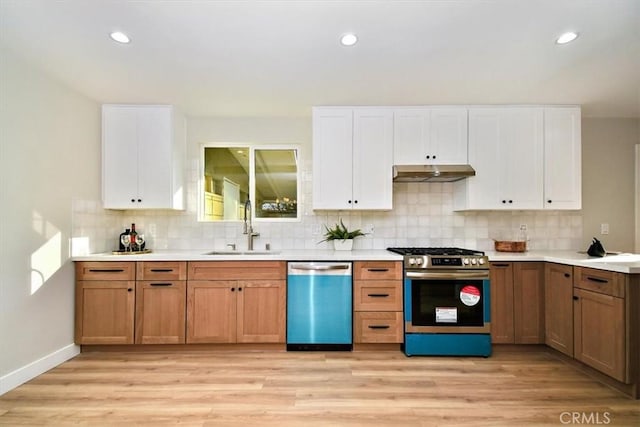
393 107 468 165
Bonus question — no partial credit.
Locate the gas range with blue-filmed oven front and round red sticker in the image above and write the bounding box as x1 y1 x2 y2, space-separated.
388 248 491 357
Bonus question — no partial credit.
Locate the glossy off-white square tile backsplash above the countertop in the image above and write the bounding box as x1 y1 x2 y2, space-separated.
72 161 582 255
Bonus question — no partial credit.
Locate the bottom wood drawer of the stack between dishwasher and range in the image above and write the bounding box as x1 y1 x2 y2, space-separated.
354 311 404 343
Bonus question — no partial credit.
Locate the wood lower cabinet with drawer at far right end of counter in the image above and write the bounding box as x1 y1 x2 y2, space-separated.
573 267 631 382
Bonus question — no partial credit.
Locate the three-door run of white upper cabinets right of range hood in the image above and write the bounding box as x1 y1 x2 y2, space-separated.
454 107 581 210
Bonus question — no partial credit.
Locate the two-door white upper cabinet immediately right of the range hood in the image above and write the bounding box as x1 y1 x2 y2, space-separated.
454 107 544 210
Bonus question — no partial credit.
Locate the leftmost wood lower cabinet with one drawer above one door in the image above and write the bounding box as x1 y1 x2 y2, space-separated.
75 262 136 344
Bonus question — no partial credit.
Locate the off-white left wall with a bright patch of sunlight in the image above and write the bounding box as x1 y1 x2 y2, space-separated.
0 48 100 393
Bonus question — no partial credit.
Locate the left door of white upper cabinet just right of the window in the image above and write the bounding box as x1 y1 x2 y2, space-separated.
313 108 352 209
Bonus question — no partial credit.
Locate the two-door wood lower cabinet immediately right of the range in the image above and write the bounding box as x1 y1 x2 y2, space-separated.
490 262 544 344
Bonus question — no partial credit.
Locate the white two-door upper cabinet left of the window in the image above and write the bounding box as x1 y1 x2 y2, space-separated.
102 105 185 209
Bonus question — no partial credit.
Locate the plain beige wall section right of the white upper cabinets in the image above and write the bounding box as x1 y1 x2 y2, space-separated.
582 118 640 252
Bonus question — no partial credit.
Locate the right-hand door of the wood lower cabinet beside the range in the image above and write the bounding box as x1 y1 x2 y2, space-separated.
513 262 544 344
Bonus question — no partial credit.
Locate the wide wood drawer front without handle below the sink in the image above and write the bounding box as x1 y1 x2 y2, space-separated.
187 261 287 280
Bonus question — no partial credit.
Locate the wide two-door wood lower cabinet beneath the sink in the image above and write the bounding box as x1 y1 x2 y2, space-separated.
186 261 286 343
